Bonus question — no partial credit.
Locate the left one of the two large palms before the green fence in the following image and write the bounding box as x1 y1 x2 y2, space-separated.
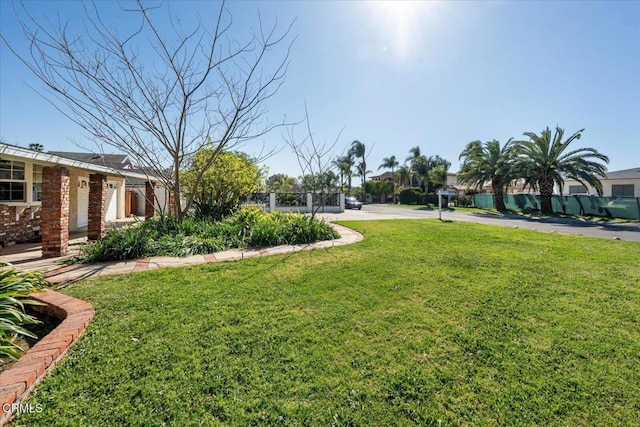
458 138 516 212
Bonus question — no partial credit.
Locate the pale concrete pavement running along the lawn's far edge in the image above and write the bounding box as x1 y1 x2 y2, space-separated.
319 205 640 243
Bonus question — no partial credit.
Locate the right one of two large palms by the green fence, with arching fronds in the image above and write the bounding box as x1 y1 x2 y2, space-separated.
518 127 609 215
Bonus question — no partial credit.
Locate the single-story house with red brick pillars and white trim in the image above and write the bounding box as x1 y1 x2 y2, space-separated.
0 143 165 258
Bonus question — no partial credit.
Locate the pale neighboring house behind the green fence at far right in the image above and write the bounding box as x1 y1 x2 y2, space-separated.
555 166 640 198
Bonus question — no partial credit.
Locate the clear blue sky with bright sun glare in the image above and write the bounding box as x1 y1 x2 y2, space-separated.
0 1 640 176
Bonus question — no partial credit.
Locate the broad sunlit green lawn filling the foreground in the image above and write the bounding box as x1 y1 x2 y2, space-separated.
15 220 640 426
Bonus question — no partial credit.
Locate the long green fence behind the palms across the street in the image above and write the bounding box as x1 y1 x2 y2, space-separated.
474 194 640 219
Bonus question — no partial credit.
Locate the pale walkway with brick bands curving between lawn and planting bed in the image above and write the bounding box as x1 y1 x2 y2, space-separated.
0 224 363 284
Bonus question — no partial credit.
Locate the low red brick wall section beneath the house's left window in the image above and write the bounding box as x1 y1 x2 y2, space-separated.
0 205 40 246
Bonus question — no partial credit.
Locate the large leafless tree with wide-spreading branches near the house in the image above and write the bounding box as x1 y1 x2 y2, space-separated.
2 0 293 219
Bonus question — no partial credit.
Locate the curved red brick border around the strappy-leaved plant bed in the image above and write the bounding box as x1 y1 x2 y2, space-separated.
0 290 95 426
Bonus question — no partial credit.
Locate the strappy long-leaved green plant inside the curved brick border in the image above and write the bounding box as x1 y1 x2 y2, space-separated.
0 263 48 359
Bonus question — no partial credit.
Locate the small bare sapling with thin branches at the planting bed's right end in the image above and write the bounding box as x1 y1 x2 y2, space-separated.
284 102 344 218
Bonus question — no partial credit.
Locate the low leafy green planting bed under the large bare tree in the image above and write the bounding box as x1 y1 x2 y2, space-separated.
80 208 339 262
